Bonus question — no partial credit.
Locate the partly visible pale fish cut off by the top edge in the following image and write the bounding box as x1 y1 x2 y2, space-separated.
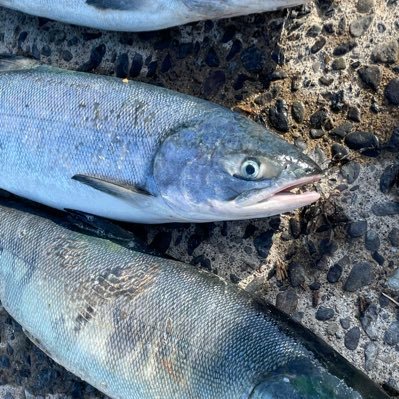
0 0 306 32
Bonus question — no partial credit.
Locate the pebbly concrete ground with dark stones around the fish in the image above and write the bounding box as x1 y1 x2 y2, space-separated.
0 0 399 399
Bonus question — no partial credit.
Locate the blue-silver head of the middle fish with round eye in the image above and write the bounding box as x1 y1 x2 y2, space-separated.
153 112 321 222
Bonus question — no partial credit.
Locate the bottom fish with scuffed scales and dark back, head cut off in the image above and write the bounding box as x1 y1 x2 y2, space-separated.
0 205 387 399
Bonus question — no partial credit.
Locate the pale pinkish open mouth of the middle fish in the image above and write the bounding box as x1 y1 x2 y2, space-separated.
234 175 321 209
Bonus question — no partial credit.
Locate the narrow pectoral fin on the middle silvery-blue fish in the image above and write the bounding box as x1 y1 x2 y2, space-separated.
72 175 154 199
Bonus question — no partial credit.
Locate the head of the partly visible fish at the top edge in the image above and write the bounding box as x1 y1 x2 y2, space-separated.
182 0 307 18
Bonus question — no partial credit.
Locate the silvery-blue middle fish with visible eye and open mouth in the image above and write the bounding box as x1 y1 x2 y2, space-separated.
0 56 320 223
